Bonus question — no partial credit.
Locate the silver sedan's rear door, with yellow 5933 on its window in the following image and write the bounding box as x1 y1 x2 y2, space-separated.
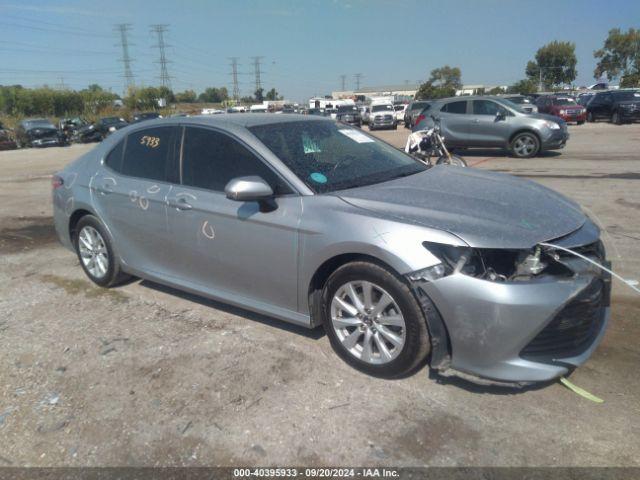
91 126 178 273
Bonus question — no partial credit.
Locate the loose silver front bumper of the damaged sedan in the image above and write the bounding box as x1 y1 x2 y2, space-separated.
415 273 610 382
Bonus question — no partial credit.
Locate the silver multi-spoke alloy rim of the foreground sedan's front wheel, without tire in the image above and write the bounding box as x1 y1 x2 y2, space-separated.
331 281 406 365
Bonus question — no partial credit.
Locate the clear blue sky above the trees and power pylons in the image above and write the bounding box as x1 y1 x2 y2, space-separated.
0 0 640 101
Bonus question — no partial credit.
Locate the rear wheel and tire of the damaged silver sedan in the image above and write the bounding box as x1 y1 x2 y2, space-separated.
73 215 129 287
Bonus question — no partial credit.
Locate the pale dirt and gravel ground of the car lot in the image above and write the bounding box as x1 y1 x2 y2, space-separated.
0 124 640 466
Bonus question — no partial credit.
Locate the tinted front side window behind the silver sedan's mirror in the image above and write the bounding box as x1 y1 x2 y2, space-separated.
182 127 291 195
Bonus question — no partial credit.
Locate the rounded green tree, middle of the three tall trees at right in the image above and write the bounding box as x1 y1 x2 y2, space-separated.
525 40 578 89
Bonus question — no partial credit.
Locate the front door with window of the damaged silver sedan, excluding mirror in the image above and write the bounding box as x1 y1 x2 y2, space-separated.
168 126 302 311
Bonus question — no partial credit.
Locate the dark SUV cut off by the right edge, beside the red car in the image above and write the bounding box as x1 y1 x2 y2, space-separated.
587 90 640 125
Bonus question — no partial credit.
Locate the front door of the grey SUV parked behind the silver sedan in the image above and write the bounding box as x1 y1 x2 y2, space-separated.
468 100 512 147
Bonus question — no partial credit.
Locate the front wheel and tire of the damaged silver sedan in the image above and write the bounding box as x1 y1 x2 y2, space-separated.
322 261 430 378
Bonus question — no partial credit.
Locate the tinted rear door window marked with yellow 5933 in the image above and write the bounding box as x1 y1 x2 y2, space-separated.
121 127 178 182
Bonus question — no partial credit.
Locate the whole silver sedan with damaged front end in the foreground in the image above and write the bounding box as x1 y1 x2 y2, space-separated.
53 114 610 382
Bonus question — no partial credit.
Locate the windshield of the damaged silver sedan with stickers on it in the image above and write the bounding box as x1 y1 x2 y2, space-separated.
249 121 426 193
